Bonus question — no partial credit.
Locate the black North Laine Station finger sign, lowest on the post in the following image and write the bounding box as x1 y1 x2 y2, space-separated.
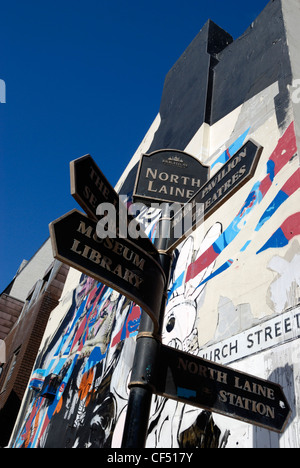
156 346 291 432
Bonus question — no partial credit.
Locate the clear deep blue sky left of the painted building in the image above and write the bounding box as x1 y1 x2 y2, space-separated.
0 0 268 292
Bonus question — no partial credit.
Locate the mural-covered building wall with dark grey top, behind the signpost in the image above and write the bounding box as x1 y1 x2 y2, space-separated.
11 0 300 448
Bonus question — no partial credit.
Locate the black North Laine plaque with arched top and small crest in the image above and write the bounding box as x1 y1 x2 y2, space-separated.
133 149 209 205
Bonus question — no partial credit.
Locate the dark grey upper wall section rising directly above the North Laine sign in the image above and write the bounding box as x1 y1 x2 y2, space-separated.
149 21 233 152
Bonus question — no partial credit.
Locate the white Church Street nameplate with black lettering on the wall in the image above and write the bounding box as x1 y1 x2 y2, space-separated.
199 307 300 364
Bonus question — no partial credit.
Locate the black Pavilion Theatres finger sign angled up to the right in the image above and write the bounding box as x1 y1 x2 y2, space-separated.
160 139 263 253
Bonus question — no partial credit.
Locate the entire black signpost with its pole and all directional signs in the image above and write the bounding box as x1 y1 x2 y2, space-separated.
50 140 291 448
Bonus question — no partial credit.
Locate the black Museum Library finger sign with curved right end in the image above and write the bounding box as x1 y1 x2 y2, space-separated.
49 210 166 331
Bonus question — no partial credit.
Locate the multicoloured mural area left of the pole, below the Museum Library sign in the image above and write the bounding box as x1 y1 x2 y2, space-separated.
12 277 139 448
